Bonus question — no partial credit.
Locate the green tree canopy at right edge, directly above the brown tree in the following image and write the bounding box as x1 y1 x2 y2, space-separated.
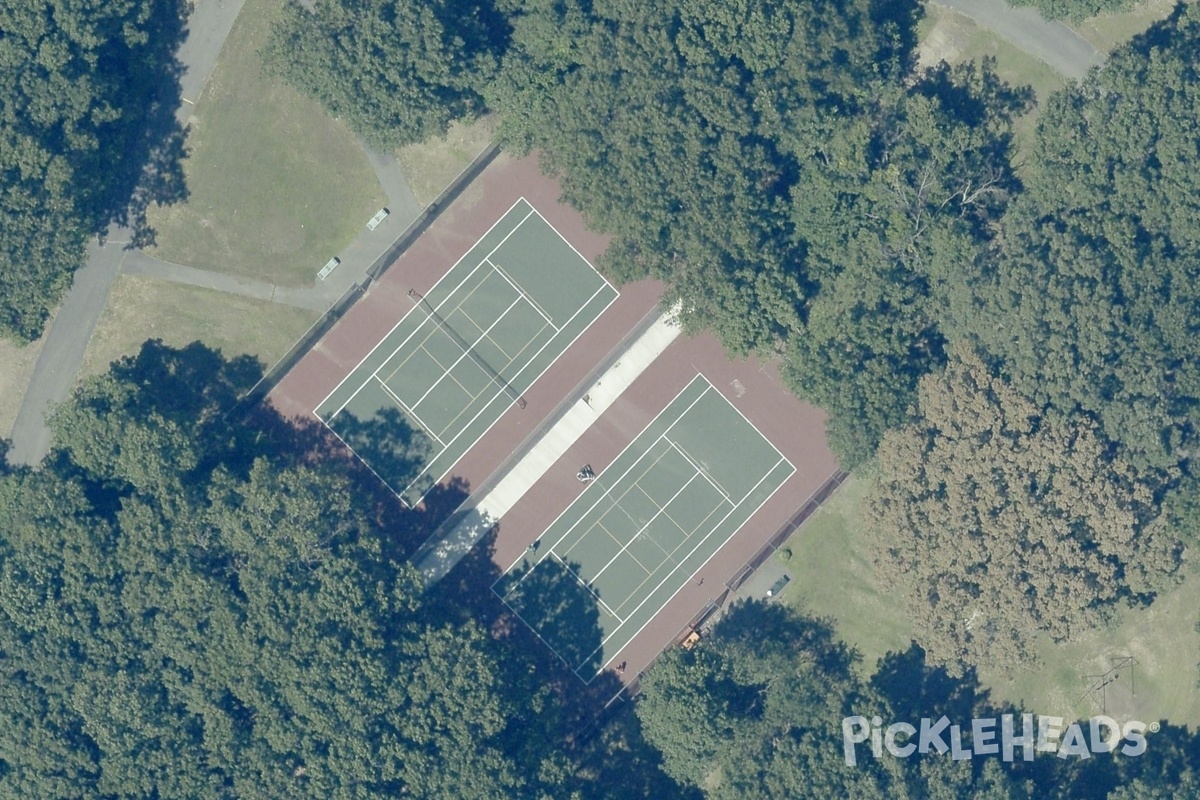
950 5 1200 473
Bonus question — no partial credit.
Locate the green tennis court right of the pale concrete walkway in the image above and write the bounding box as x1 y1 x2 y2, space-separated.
493 375 796 681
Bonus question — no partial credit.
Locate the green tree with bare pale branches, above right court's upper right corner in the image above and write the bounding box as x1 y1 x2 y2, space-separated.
784 61 1031 468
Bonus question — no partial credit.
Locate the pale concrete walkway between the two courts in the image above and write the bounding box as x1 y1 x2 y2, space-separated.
413 313 679 585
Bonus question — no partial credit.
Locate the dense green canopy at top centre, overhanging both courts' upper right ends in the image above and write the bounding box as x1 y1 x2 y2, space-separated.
488 0 1028 465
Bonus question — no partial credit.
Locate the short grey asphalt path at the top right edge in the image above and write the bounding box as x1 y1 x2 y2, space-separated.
935 0 1104 80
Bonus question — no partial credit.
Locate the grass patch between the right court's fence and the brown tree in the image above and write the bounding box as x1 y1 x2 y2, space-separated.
775 471 912 674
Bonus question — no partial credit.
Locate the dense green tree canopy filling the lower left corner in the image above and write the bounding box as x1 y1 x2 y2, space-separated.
0 343 671 800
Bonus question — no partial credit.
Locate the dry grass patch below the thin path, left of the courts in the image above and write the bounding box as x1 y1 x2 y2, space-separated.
79 275 319 378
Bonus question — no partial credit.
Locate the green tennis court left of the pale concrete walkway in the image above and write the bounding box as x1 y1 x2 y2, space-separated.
316 198 617 505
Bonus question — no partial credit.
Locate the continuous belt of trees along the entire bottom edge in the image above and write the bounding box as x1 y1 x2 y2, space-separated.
0 342 1200 800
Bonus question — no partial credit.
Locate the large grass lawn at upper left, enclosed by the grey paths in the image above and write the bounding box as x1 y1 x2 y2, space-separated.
149 0 385 285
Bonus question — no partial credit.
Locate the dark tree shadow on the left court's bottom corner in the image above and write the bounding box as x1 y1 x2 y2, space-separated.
330 408 433 495
